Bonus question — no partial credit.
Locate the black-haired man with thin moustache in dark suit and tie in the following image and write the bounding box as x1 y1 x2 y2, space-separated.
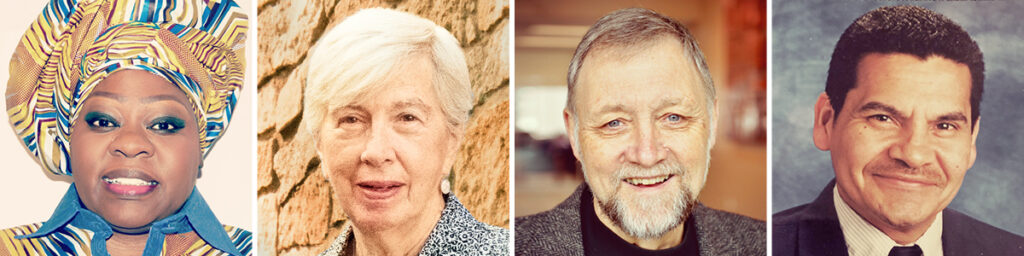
772 6 1024 256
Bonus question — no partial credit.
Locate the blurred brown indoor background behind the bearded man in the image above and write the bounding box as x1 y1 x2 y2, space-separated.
513 0 767 220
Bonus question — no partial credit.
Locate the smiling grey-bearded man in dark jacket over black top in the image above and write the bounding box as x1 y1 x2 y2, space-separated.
515 8 766 255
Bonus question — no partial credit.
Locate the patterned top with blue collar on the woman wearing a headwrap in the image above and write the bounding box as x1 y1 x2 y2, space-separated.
0 184 252 256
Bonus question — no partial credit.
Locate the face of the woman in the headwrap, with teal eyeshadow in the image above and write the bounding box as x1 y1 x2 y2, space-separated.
71 70 202 229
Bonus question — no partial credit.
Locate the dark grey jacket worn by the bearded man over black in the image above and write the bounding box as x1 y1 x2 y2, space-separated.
515 183 767 255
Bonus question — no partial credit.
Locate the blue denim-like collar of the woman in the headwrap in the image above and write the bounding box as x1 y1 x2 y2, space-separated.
15 183 242 256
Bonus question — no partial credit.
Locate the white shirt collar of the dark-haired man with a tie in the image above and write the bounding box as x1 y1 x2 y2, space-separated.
833 186 942 256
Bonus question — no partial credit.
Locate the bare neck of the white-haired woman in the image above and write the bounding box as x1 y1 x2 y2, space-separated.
352 197 444 255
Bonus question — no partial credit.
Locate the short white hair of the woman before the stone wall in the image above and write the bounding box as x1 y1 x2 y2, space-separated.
303 8 473 141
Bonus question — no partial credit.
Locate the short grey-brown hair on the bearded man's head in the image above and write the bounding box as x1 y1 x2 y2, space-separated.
565 8 715 116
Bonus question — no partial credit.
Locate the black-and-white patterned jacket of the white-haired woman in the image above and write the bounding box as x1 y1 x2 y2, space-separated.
319 195 509 256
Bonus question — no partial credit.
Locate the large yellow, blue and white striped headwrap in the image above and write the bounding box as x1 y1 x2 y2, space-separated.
6 0 248 175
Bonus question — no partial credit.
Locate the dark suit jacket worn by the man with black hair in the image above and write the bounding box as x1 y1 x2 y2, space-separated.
772 180 1024 256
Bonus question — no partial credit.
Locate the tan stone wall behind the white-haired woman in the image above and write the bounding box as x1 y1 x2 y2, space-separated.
256 0 509 252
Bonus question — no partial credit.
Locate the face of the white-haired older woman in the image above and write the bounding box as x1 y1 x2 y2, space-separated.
317 56 458 229
